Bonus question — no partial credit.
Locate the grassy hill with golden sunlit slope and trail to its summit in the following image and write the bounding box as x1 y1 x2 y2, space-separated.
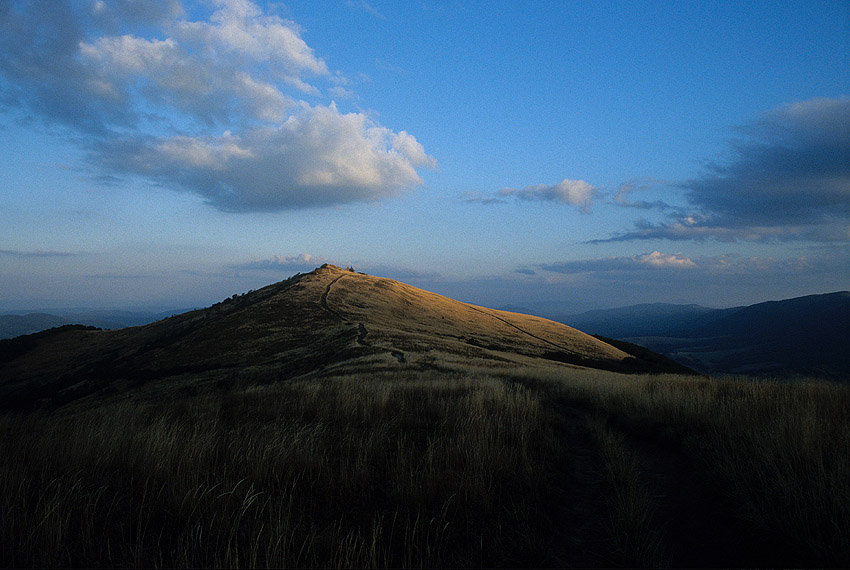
0 265 689 408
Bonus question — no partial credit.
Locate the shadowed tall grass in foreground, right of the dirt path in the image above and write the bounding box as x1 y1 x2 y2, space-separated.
532 371 850 567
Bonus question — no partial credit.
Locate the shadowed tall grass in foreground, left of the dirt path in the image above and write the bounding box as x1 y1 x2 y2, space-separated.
0 370 559 567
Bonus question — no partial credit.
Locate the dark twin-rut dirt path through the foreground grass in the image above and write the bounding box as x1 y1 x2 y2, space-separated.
536 394 760 568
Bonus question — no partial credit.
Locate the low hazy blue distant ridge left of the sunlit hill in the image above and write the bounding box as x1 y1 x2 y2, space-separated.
0 309 182 339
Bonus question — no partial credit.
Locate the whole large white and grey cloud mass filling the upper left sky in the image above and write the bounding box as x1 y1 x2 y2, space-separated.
0 0 436 212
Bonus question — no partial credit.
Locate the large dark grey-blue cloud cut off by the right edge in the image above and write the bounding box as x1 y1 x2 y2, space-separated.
603 97 850 242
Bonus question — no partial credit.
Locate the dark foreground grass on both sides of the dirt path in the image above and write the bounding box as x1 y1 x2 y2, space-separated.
0 369 850 567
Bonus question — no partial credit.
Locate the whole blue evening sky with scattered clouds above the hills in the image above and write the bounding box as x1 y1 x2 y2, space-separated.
0 0 850 314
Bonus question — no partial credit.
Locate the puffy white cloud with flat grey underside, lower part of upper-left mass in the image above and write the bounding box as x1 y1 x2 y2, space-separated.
94 105 433 211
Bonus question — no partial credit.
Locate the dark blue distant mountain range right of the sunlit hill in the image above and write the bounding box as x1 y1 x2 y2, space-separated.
555 291 850 380
